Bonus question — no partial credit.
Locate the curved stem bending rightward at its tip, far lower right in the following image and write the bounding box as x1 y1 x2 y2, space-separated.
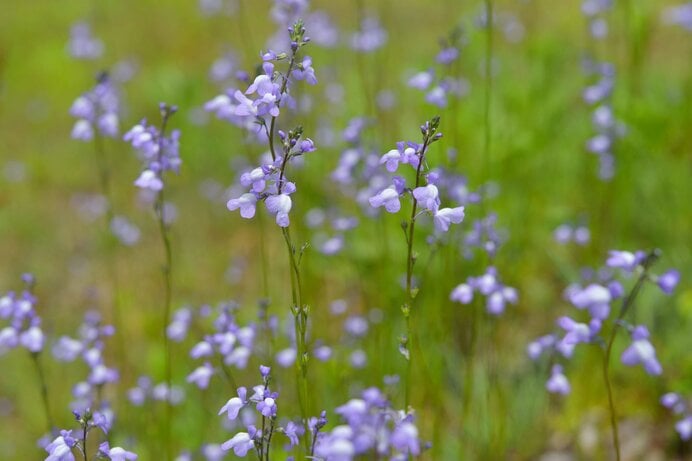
603 250 659 461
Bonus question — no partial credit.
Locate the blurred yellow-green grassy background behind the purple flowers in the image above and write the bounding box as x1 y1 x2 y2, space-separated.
0 0 692 460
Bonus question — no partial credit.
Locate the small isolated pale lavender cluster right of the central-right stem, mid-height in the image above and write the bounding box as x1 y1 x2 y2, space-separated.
449 266 519 315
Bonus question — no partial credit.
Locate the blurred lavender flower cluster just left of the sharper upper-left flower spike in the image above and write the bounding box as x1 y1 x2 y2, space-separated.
70 73 119 141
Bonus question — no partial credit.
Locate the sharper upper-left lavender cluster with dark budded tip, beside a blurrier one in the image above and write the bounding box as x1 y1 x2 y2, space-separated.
123 103 181 192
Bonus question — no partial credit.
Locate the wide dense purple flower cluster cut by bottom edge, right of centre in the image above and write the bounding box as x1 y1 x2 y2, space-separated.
314 387 423 461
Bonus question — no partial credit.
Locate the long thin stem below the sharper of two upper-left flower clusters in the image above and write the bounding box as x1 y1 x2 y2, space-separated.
154 109 173 460
